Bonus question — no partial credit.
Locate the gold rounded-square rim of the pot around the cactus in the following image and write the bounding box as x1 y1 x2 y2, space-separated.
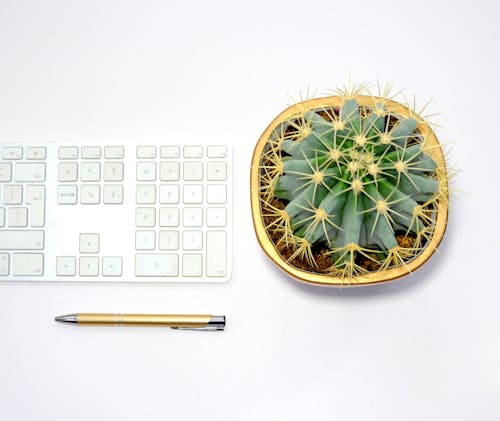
250 95 448 287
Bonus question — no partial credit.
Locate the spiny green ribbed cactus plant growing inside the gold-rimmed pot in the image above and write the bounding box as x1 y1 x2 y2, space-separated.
262 85 446 278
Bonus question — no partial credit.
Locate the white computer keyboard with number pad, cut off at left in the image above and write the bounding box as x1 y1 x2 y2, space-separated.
0 142 232 282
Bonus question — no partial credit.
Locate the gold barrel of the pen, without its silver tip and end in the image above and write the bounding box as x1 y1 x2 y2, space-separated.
77 313 212 329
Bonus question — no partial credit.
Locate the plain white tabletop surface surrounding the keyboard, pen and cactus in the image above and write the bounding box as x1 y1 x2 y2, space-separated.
0 0 500 421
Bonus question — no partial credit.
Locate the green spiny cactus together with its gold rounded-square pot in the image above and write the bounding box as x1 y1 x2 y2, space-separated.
251 85 448 286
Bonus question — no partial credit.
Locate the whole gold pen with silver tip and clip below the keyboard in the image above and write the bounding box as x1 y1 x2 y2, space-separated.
55 313 226 330
